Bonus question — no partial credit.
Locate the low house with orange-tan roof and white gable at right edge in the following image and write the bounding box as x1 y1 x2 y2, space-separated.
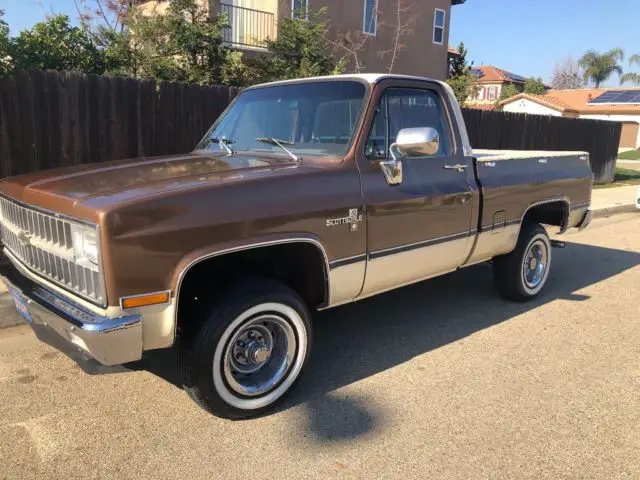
500 87 640 148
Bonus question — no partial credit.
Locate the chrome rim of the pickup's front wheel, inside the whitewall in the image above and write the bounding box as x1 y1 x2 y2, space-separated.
222 312 297 397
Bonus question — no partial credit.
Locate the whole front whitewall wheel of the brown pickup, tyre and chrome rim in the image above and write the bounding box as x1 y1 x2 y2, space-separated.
180 278 312 419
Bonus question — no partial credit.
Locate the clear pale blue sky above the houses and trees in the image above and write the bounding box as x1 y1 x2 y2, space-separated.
0 0 640 86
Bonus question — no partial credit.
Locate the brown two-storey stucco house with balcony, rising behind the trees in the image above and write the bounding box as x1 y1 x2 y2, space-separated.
136 0 466 80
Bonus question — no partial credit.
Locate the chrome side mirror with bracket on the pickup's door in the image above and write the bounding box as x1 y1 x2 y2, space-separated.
380 127 440 185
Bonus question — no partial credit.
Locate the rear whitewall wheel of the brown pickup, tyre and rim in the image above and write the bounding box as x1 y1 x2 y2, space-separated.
493 223 551 302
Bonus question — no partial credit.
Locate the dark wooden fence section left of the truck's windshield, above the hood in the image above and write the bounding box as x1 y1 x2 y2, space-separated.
0 71 239 177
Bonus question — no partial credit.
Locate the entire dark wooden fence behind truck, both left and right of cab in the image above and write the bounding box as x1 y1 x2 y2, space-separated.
0 71 621 183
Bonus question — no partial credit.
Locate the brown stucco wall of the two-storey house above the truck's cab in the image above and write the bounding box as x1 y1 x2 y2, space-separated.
280 0 452 80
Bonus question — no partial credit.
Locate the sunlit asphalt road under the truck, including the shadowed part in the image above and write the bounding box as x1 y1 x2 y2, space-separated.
0 214 640 480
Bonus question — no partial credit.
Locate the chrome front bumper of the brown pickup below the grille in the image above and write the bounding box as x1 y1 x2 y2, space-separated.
0 253 143 366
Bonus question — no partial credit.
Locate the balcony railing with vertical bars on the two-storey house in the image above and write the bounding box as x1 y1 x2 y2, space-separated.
220 3 275 48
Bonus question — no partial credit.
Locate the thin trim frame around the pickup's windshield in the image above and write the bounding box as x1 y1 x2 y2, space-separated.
193 75 374 159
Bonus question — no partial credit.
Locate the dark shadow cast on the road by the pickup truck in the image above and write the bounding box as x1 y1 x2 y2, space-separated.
135 243 640 441
